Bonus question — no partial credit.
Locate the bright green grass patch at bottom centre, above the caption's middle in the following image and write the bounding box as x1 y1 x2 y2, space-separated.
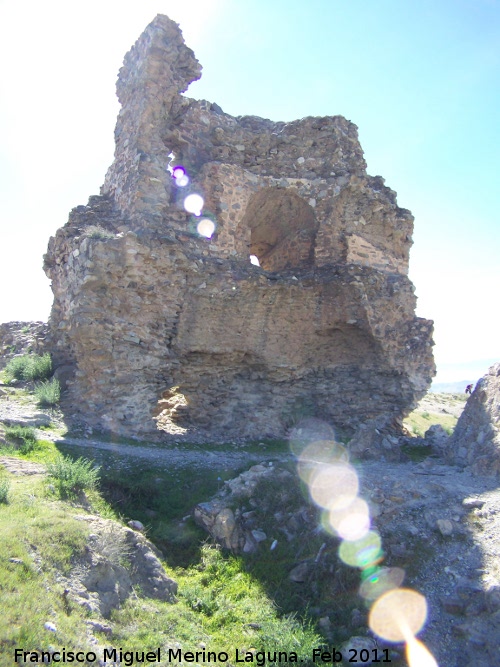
112 546 321 665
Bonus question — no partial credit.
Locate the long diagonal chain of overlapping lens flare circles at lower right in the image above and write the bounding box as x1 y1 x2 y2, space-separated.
290 418 438 667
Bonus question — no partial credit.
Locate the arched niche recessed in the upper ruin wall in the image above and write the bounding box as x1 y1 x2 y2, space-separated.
241 188 318 271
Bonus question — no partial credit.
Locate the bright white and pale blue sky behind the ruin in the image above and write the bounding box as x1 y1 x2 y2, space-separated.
0 0 500 381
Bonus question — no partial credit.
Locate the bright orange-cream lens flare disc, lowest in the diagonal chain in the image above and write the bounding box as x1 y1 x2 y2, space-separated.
368 588 427 642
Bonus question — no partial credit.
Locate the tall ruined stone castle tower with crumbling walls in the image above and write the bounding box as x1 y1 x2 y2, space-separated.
45 16 434 440
